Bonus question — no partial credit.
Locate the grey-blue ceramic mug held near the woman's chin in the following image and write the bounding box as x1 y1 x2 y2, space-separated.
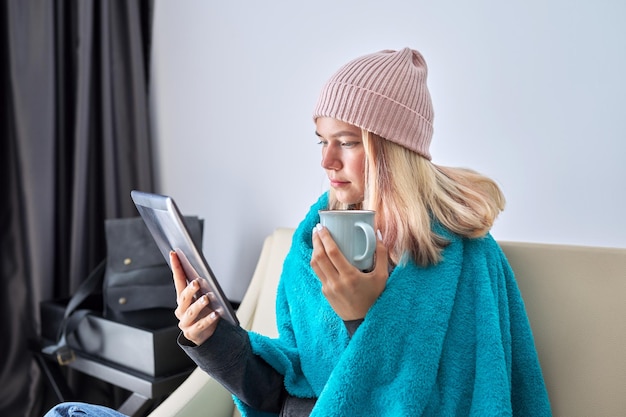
319 210 376 271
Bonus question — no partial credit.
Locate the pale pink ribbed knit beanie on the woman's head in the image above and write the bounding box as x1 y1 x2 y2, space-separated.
313 48 434 160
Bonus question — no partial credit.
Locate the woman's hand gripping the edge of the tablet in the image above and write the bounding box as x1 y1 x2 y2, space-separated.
170 251 220 345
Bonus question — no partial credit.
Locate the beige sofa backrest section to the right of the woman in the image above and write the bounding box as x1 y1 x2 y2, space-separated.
500 242 626 417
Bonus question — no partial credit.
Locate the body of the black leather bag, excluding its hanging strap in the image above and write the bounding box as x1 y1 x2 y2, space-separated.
102 216 203 329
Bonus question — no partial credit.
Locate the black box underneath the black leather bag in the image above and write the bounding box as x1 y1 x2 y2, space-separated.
40 297 195 376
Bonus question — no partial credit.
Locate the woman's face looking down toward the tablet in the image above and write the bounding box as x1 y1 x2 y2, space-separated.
315 117 365 204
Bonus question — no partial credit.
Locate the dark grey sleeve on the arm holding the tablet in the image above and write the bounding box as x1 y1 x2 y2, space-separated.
178 320 286 413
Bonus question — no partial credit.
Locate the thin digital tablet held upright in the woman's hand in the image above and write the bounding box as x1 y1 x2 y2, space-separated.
130 190 239 326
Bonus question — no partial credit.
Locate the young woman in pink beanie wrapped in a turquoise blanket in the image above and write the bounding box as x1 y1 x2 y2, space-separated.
46 48 551 416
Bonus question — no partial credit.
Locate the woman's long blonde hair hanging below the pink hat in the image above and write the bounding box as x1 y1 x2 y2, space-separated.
329 130 505 266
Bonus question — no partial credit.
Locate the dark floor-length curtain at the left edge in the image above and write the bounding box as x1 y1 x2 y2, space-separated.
0 0 154 416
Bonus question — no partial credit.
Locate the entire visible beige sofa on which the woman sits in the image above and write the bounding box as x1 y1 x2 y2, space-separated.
150 229 626 417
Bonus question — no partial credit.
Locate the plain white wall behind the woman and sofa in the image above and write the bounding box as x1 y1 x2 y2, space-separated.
152 0 626 299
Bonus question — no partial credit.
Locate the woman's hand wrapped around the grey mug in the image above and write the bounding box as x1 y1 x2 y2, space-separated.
311 227 389 321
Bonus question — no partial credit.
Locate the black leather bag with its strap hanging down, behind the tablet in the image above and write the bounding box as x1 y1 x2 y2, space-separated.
43 216 204 365
